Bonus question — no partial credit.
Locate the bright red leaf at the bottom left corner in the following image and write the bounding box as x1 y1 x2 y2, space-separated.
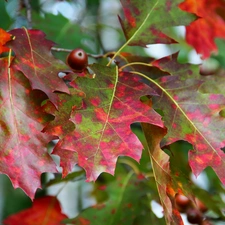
3 196 67 225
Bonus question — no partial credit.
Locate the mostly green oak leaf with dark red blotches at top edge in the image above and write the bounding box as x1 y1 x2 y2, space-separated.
119 0 194 47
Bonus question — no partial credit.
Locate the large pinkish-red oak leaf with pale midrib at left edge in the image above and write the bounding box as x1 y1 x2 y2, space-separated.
0 58 56 199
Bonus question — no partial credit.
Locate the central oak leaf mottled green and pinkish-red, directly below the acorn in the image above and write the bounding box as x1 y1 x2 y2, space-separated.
53 64 163 181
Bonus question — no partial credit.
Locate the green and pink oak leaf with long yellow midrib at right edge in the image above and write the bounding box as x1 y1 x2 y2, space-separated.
125 54 225 190
